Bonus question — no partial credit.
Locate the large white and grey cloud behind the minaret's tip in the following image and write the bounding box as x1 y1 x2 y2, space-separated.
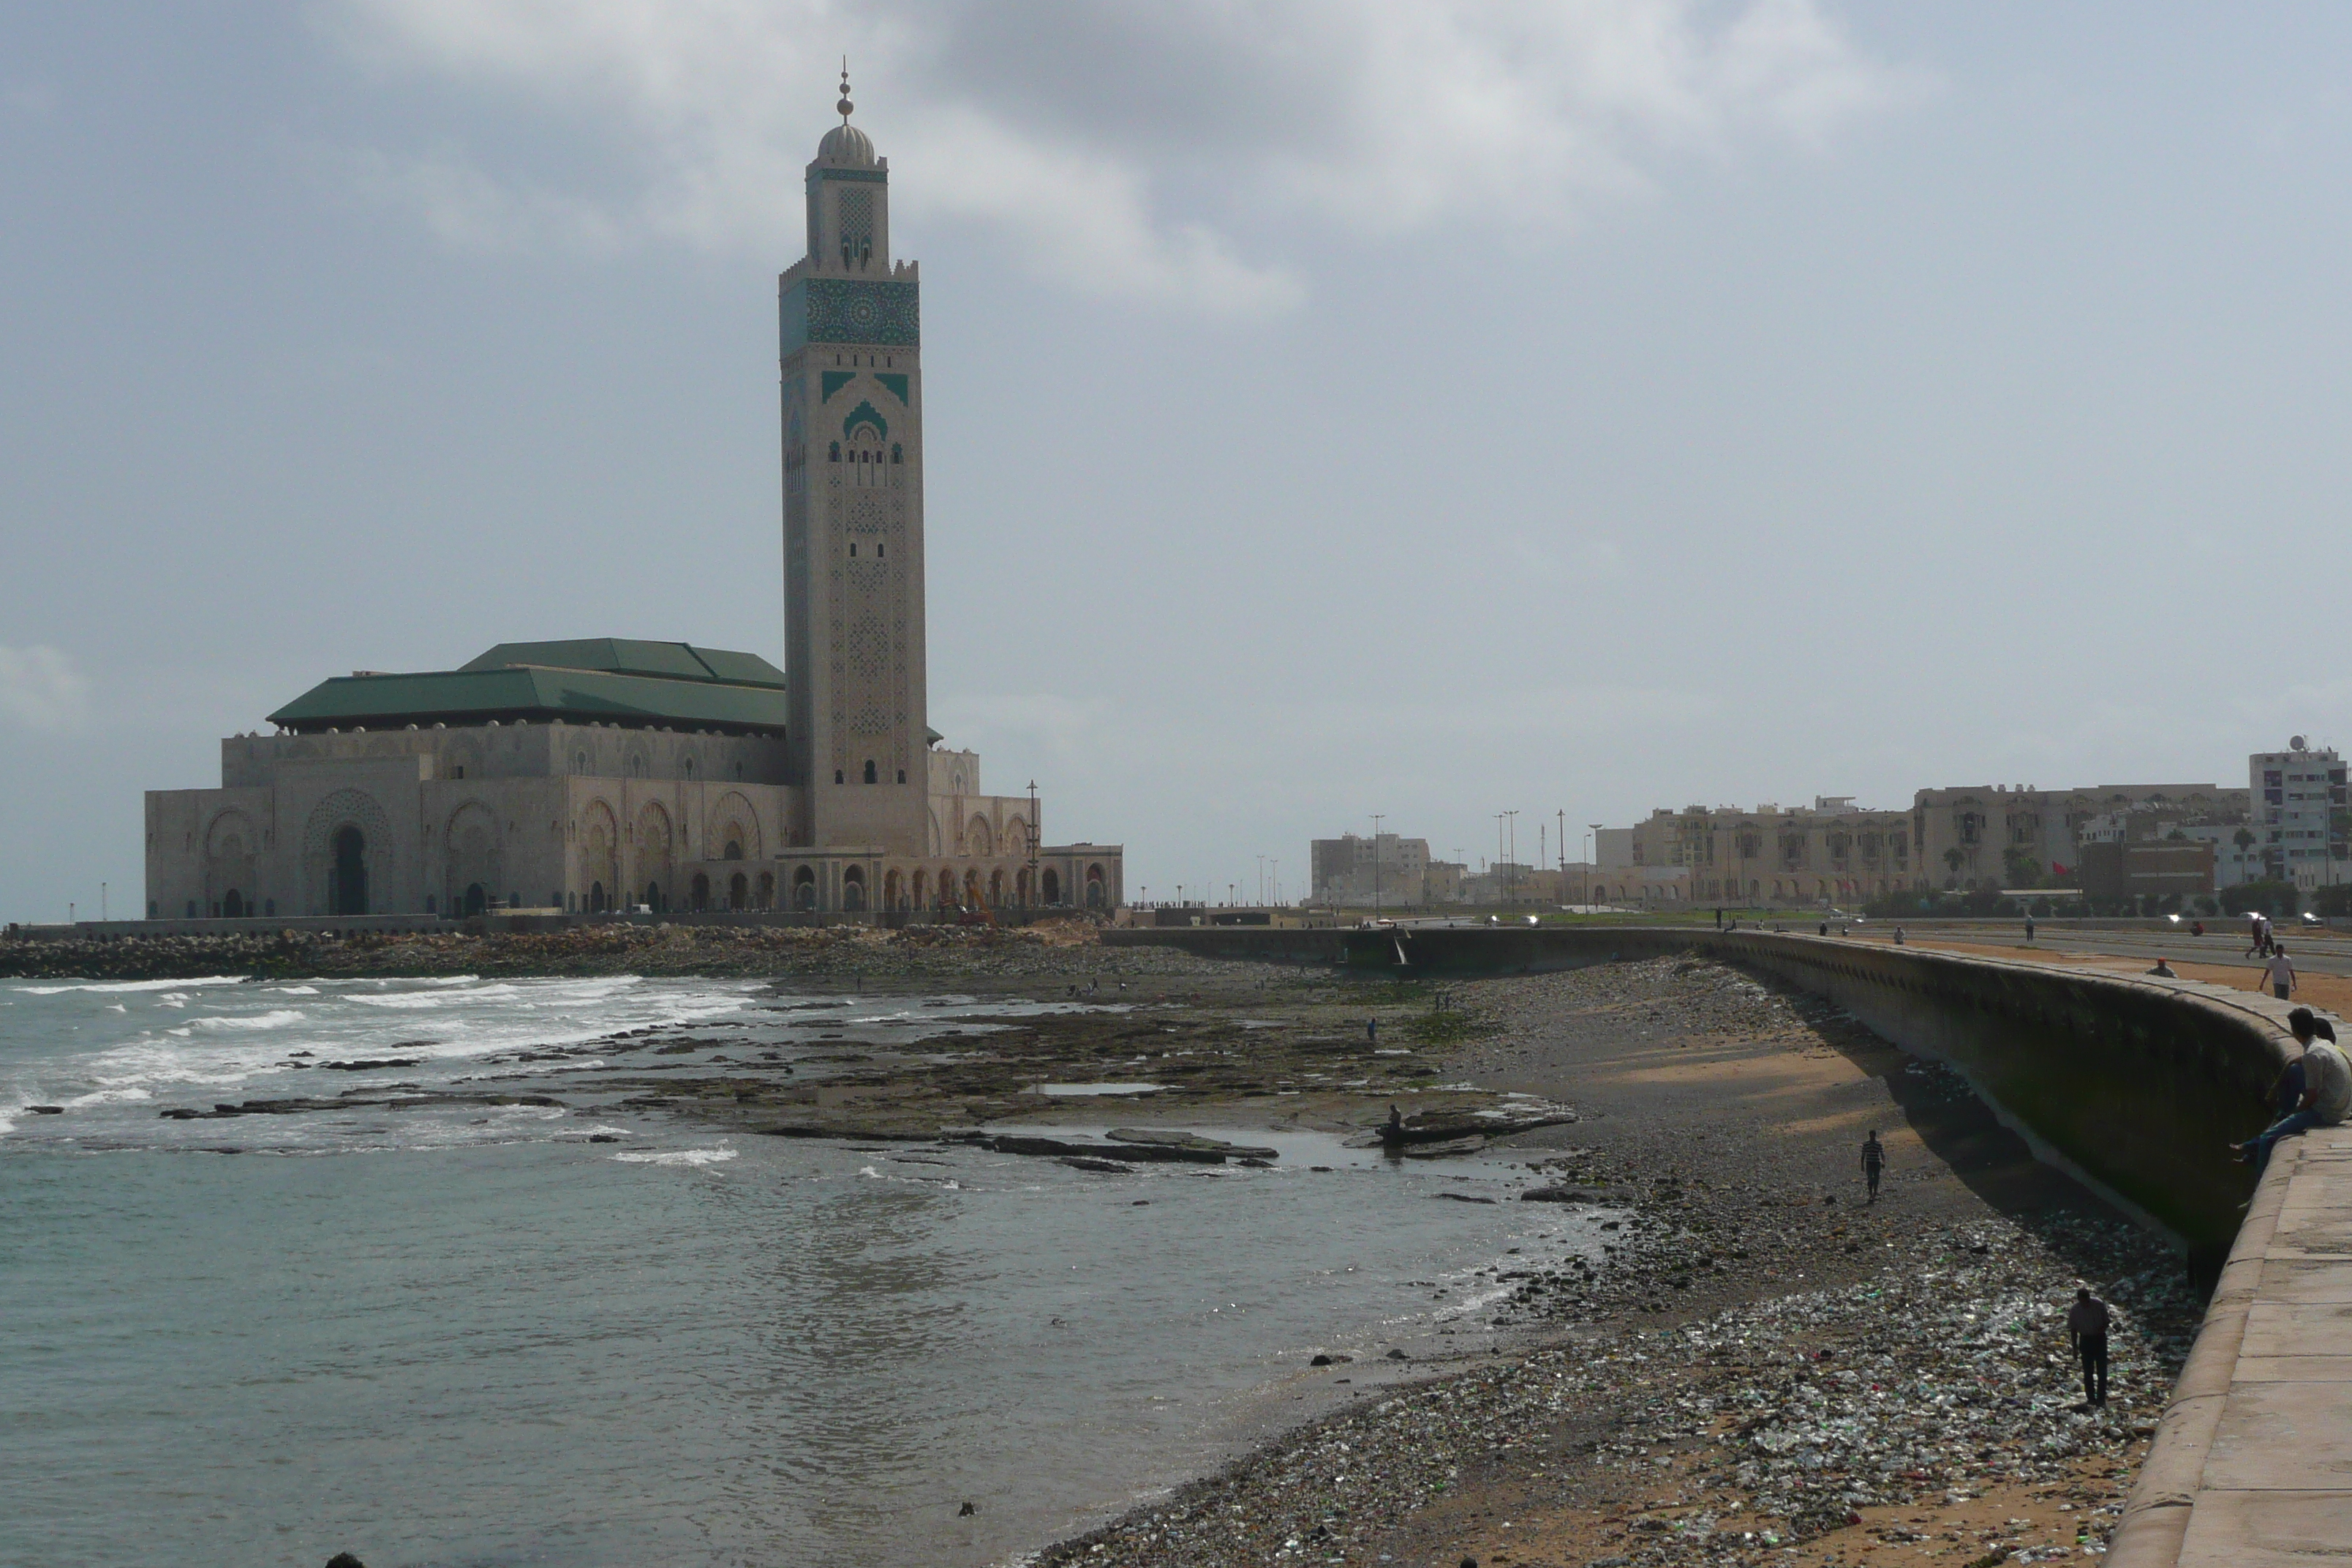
325 0 1924 315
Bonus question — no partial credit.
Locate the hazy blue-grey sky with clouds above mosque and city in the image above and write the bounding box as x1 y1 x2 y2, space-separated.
0 0 2352 919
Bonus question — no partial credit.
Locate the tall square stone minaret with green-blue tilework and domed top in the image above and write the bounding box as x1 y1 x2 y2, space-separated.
778 70 932 856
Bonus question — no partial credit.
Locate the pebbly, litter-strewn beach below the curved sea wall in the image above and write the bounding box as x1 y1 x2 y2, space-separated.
1033 962 2201 1568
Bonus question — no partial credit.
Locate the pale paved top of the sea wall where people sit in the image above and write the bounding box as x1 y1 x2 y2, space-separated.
2110 983 2352 1568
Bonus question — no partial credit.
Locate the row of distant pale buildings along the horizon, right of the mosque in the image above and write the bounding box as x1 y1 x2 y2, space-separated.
1310 736 2352 912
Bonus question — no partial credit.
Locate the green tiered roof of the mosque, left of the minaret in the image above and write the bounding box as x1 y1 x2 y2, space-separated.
271 637 785 734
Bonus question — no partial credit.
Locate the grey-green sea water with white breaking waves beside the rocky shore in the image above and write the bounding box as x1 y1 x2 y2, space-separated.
0 976 1599 1568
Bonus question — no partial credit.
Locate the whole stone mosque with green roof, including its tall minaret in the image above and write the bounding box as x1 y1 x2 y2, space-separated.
146 75 1124 919
